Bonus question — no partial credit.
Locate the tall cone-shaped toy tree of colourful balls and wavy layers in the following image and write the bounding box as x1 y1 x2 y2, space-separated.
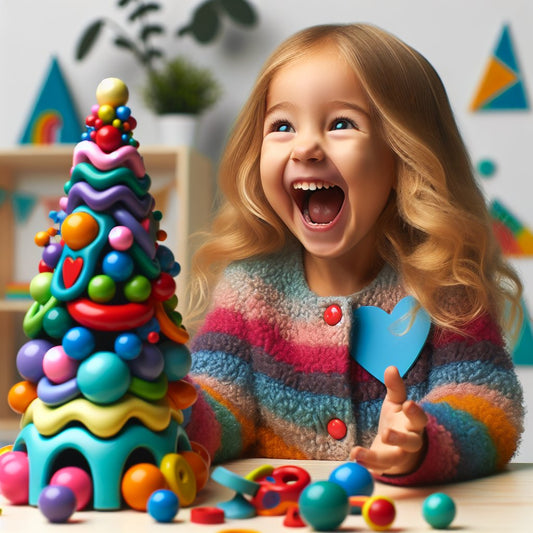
0 78 209 510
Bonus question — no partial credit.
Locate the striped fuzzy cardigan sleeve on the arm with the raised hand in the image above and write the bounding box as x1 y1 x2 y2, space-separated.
380 316 524 485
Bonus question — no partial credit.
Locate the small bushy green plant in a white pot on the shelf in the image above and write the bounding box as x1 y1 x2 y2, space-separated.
143 56 221 145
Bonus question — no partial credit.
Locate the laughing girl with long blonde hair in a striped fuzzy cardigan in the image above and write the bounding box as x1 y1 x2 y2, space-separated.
188 24 523 484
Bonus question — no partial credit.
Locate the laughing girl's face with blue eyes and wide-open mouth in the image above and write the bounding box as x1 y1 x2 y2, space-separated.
260 45 395 268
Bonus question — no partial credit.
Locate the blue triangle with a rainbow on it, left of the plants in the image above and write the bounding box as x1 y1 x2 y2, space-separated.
20 57 83 144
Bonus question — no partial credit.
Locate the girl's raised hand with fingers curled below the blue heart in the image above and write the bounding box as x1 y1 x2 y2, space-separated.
350 366 427 475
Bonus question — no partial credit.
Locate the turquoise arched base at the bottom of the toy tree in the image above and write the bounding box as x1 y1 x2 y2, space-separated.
13 420 191 510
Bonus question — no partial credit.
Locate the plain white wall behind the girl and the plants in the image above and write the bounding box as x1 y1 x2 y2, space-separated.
0 0 533 461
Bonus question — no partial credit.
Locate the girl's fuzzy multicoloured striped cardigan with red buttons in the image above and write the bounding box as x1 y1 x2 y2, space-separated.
188 244 523 485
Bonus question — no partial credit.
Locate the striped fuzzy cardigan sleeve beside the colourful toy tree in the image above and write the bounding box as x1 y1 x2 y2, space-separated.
187 268 257 462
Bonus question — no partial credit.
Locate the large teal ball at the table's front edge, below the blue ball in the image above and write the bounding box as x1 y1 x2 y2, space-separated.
298 481 350 531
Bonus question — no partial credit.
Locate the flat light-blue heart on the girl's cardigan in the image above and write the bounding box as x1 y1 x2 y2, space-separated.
350 296 431 383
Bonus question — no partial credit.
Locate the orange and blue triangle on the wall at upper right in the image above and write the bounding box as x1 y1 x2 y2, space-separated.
470 25 529 111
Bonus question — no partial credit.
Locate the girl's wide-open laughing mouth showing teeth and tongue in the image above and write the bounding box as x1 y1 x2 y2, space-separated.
292 181 344 225
